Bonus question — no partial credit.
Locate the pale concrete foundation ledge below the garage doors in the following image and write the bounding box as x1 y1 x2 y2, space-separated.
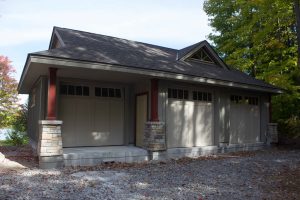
63 143 265 166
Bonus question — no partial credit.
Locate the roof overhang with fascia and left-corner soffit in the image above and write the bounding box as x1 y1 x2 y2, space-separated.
18 54 283 94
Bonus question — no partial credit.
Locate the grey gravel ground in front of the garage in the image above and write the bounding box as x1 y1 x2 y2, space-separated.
0 149 300 200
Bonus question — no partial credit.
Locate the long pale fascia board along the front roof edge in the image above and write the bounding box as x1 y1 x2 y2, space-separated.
30 56 282 93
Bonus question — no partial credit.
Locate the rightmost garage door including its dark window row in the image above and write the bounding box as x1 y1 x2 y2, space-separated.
229 95 260 144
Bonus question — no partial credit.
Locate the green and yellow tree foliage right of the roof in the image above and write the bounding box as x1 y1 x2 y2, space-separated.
204 0 300 138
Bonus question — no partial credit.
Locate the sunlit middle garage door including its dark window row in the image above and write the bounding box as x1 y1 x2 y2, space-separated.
166 88 213 148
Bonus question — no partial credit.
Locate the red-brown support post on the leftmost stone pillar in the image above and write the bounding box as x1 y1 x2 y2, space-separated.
46 68 57 120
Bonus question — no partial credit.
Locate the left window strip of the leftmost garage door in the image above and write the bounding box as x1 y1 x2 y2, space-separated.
59 85 90 96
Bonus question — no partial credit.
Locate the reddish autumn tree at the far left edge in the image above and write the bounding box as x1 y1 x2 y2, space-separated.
0 56 18 128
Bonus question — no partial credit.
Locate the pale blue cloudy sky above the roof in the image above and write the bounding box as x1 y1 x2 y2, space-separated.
0 0 212 83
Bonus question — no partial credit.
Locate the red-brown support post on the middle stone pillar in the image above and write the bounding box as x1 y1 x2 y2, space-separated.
151 79 159 122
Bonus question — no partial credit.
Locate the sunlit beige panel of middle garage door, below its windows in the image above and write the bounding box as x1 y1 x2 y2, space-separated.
166 100 213 148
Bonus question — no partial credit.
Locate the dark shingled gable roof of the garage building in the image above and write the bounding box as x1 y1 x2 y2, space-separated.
24 27 278 92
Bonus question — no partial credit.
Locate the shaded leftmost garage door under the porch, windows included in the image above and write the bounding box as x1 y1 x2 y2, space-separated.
59 84 124 147
